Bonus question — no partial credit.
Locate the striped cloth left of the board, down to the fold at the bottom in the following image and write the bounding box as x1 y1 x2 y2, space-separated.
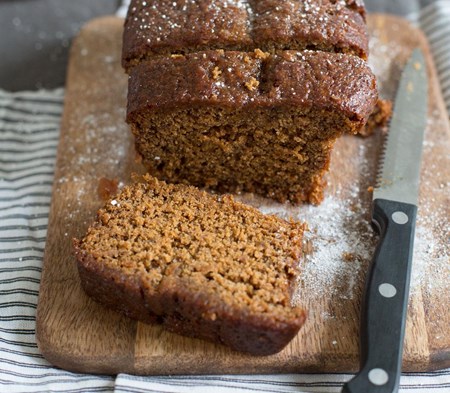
0 89 114 392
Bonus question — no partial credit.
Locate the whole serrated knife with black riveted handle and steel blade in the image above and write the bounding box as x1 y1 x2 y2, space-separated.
342 49 428 393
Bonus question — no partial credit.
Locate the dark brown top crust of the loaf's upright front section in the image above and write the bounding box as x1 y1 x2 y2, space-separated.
127 49 378 122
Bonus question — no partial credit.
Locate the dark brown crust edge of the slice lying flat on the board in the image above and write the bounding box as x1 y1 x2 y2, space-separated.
74 253 306 356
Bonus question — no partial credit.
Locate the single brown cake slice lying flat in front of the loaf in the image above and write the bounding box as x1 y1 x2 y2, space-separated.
74 175 305 355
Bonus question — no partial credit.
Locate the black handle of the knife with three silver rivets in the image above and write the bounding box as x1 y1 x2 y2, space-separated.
342 199 417 393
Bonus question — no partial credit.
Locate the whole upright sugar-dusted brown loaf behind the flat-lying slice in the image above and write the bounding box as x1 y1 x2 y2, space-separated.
122 0 378 203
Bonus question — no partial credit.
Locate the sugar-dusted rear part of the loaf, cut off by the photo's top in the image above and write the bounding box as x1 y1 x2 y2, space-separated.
122 0 368 69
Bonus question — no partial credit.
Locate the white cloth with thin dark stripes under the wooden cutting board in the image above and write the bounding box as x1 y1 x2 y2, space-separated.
0 0 450 393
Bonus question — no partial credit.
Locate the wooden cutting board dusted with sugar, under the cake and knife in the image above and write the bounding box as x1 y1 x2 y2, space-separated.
36 15 450 374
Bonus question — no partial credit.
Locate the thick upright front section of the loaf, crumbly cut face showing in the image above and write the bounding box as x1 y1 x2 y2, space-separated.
127 50 378 203
